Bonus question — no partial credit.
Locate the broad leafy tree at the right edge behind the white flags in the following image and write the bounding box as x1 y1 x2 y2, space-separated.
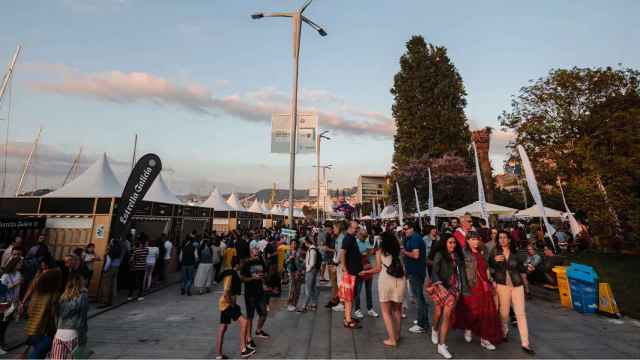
500 67 640 249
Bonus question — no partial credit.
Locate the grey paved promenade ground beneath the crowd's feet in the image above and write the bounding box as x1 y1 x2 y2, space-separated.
5 280 640 359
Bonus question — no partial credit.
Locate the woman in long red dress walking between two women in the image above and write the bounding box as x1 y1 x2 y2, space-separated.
454 232 504 350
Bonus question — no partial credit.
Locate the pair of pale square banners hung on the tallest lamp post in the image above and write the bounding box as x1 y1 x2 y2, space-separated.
271 113 318 154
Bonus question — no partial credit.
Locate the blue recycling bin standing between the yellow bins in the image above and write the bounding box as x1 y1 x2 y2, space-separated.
567 263 599 314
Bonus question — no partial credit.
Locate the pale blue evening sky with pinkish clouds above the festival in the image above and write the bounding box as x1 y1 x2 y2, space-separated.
0 0 640 194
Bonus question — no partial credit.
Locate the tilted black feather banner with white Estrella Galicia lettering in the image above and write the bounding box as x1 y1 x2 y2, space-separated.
111 154 162 239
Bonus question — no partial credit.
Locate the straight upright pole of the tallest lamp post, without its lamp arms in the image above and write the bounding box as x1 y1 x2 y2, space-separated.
289 12 302 229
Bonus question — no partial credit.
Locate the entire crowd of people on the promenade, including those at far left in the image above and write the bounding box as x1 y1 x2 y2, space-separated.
0 215 563 358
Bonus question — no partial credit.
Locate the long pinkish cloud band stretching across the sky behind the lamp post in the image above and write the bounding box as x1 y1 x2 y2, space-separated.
30 65 395 138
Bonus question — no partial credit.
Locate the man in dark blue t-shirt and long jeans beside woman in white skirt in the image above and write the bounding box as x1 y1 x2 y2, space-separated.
402 223 429 334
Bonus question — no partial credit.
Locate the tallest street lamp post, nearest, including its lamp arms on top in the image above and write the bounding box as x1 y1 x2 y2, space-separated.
251 0 327 228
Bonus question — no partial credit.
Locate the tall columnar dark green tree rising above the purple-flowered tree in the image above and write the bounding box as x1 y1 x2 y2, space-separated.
391 36 470 169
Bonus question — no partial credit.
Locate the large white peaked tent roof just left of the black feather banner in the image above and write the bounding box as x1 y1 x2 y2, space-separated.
44 153 124 197
